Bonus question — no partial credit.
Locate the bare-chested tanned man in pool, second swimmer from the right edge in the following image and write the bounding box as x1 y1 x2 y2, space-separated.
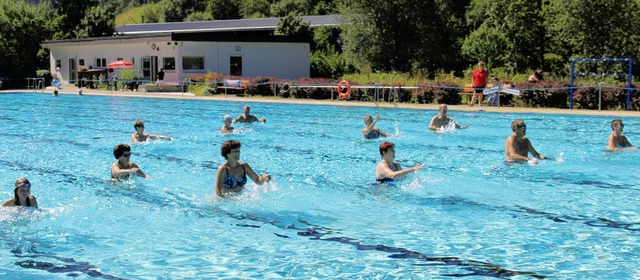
505 119 547 161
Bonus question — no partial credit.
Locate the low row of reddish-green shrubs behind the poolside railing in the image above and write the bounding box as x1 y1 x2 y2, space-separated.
185 73 640 110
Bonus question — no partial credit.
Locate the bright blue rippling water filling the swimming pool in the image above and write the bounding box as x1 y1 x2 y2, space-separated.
0 93 640 279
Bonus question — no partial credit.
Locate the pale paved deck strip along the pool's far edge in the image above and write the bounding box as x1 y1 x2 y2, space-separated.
5 85 640 117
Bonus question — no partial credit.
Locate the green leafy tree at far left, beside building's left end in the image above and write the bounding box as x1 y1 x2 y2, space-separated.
0 0 54 78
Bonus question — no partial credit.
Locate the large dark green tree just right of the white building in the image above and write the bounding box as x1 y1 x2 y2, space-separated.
341 0 461 74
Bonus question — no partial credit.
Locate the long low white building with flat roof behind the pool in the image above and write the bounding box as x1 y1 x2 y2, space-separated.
42 16 338 84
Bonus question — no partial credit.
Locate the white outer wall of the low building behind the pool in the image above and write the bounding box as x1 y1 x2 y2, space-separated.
44 38 310 84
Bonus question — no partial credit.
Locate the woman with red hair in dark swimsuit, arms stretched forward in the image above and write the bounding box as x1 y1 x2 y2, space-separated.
376 142 424 184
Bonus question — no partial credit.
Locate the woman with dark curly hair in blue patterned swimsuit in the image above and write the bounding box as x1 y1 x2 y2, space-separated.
214 140 271 197
